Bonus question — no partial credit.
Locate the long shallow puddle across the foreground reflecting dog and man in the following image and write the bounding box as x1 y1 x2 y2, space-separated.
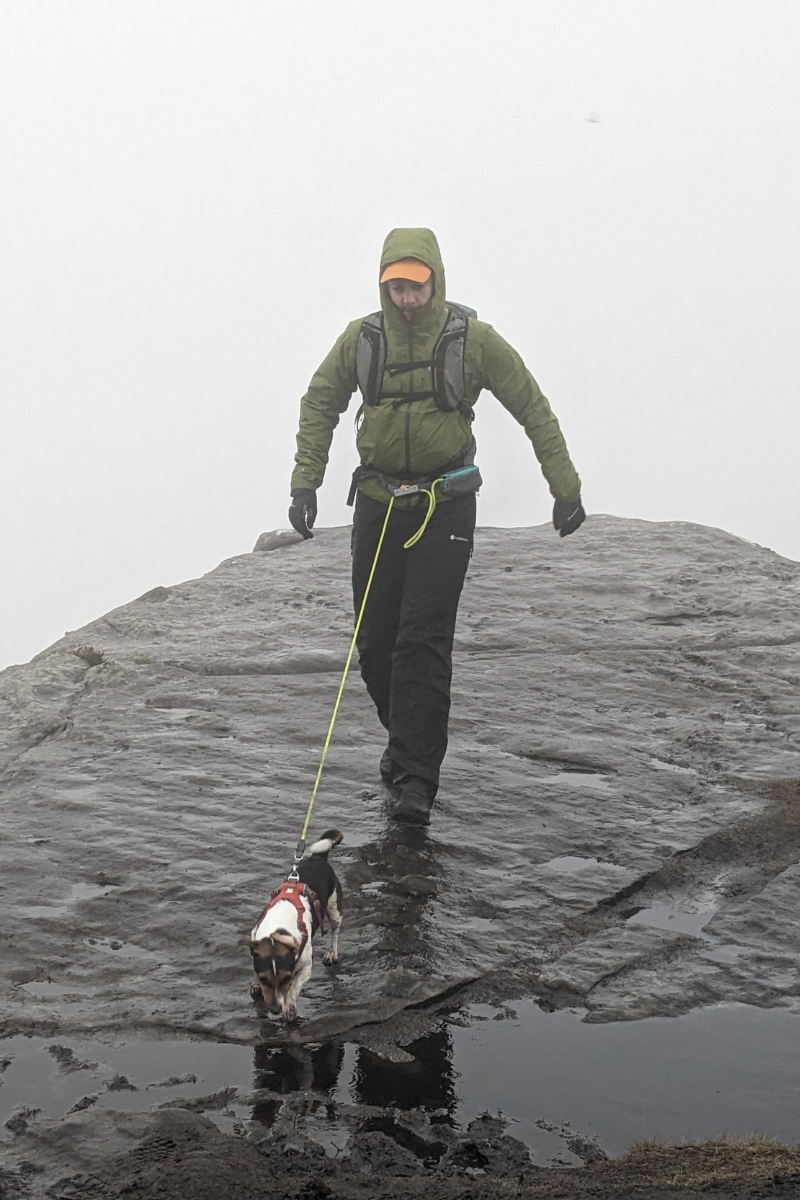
0 1003 800 1165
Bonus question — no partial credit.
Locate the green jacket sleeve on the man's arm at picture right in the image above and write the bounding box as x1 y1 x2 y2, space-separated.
481 322 581 500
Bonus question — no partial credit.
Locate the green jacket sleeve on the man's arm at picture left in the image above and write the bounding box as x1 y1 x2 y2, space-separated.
291 320 361 490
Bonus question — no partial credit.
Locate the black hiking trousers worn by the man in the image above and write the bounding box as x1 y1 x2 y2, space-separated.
353 492 476 797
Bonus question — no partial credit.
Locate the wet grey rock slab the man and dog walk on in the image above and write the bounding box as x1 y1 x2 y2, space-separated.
0 517 800 1043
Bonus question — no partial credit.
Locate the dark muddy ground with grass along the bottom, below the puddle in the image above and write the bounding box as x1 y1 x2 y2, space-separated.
17 1111 800 1200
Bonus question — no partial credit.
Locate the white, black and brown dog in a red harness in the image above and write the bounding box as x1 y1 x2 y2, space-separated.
249 829 342 1021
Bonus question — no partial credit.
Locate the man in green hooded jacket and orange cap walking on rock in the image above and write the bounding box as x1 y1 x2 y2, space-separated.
289 229 585 824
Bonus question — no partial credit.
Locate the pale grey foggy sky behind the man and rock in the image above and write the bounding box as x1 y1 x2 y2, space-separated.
0 0 800 666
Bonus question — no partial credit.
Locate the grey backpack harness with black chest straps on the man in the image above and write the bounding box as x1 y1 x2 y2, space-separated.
355 300 477 413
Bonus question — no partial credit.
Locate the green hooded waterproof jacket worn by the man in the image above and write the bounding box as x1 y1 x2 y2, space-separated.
291 229 581 505
